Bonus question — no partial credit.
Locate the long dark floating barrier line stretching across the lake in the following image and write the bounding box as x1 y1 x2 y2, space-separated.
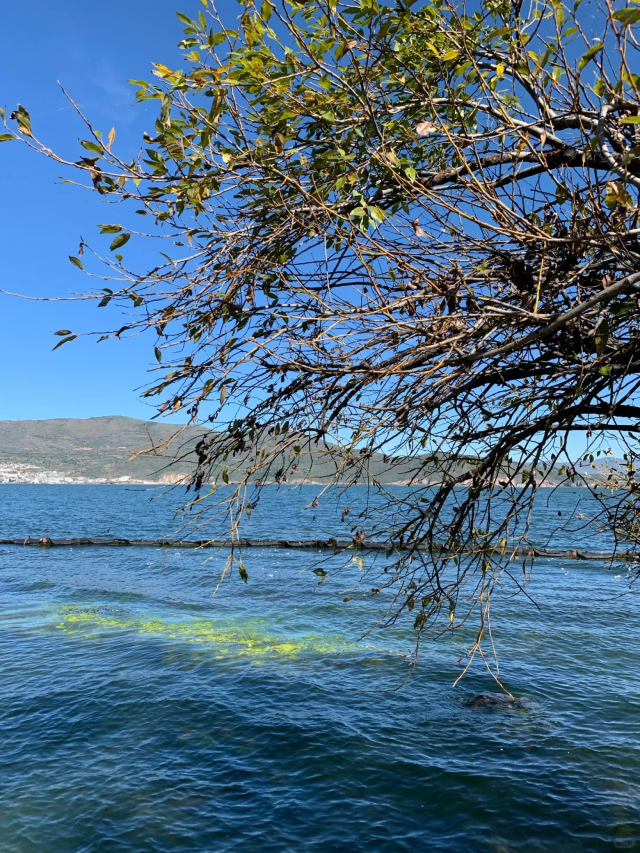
0 536 640 562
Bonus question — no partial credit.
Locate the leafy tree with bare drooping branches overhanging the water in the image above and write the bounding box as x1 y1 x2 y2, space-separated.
3 0 640 672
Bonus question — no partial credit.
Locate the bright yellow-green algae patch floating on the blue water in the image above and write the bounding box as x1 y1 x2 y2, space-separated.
55 607 354 660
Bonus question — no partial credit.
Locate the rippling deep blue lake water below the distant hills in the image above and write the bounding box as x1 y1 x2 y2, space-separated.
0 486 640 853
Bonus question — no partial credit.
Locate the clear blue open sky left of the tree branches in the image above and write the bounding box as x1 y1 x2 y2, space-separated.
0 0 208 420
